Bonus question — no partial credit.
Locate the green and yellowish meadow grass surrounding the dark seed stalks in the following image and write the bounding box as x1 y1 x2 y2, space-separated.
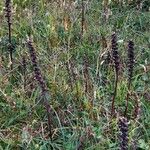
0 0 150 150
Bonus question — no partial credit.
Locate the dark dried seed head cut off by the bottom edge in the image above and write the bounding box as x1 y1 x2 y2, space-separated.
119 117 129 150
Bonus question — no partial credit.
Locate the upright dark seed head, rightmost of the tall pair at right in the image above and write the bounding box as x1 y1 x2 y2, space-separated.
128 41 134 82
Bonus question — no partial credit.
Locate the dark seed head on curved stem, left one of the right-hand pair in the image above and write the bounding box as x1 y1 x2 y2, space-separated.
111 33 119 72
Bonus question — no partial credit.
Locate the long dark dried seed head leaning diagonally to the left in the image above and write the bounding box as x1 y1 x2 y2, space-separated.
27 38 47 93
